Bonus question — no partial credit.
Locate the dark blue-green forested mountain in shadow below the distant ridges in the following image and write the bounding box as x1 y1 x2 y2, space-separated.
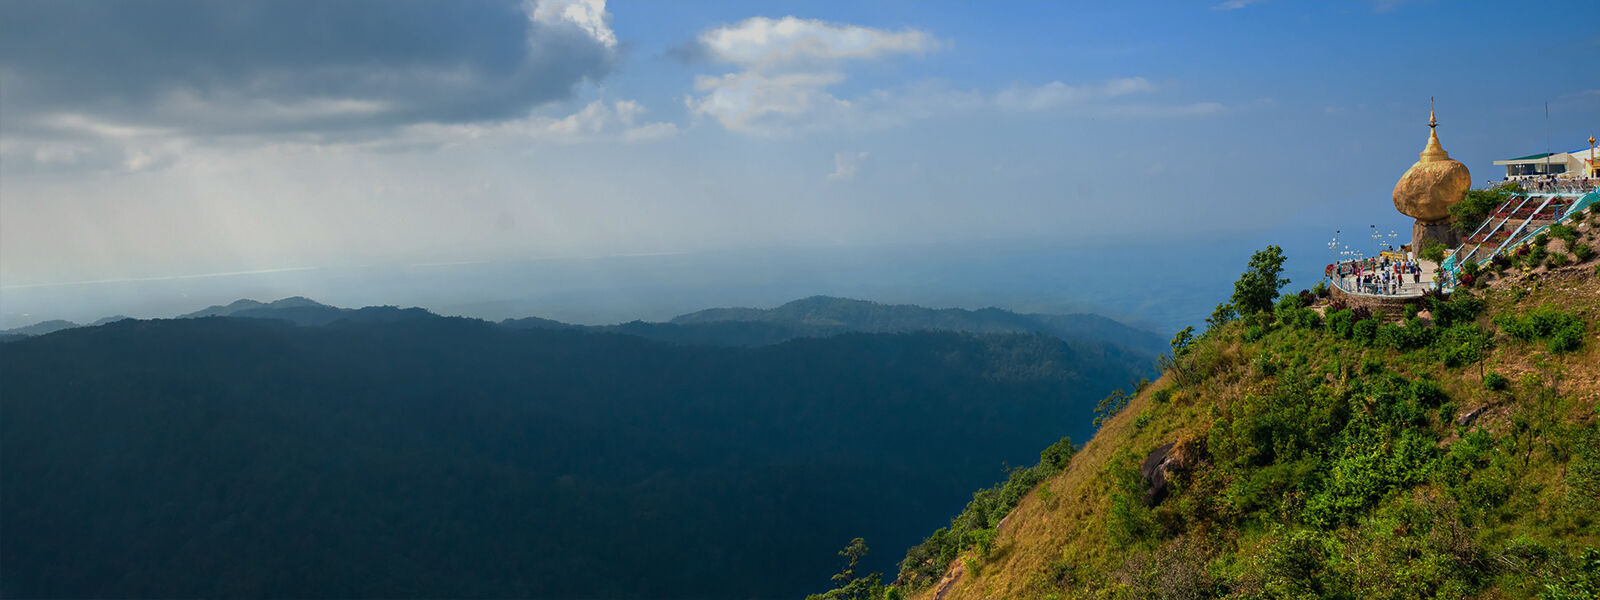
0 315 1144 598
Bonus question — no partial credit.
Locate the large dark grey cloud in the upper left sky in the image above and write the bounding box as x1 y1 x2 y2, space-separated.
0 0 616 134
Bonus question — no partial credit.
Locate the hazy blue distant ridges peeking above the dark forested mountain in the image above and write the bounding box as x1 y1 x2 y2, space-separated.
0 296 1166 360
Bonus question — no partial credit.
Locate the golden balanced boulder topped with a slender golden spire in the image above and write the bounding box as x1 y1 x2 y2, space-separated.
1394 101 1472 251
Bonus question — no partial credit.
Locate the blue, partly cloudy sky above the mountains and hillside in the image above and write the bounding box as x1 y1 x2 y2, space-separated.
0 0 1600 326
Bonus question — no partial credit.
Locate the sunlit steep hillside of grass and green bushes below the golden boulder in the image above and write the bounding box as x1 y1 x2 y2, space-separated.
826 240 1600 600
